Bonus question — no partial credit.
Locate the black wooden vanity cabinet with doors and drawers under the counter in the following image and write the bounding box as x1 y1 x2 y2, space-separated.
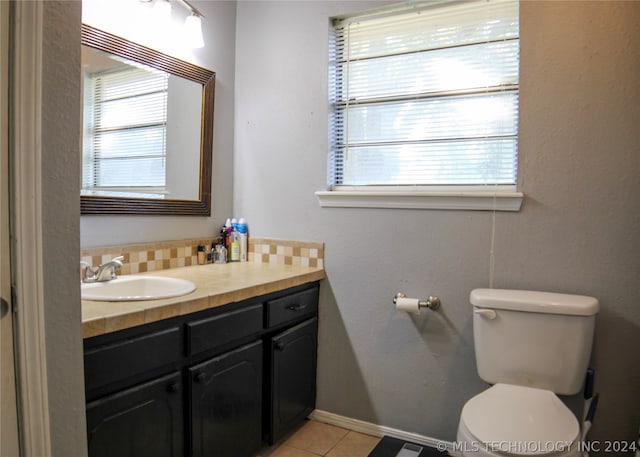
84 283 318 457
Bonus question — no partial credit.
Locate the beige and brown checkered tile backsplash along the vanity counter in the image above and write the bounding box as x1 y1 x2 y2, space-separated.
80 237 324 275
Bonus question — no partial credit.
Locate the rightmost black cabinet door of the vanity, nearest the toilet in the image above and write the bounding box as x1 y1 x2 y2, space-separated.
269 317 318 444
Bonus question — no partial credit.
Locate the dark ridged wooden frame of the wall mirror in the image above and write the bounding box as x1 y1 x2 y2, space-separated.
80 24 216 216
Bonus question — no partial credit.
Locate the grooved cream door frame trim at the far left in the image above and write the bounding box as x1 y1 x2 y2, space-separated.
9 1 51 457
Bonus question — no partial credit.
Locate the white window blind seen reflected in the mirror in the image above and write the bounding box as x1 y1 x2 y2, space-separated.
83 67 168 197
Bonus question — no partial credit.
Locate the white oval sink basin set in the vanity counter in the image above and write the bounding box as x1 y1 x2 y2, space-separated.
82 275 196 301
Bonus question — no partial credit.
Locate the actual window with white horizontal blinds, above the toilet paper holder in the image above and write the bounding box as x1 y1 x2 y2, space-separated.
318 0 521 209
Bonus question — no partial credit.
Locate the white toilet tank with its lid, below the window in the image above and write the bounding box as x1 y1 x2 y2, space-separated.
470 289 599 395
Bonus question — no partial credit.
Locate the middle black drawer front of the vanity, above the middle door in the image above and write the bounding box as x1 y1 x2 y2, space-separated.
187 304 262 355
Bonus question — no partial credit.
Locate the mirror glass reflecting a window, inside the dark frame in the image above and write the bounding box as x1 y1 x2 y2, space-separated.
82 46 202 200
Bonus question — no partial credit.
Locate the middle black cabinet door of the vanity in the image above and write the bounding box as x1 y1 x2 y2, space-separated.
189 341 262 457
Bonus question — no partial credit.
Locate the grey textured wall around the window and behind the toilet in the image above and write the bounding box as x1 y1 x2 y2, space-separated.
234 1 640 448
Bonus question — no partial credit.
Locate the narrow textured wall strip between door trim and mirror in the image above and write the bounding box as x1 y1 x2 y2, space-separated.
41 1 86 457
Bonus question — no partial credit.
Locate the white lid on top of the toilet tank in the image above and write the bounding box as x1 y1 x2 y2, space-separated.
469 289 599 316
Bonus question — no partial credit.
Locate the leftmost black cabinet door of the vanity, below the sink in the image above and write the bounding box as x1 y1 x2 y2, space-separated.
87 372 184 457
